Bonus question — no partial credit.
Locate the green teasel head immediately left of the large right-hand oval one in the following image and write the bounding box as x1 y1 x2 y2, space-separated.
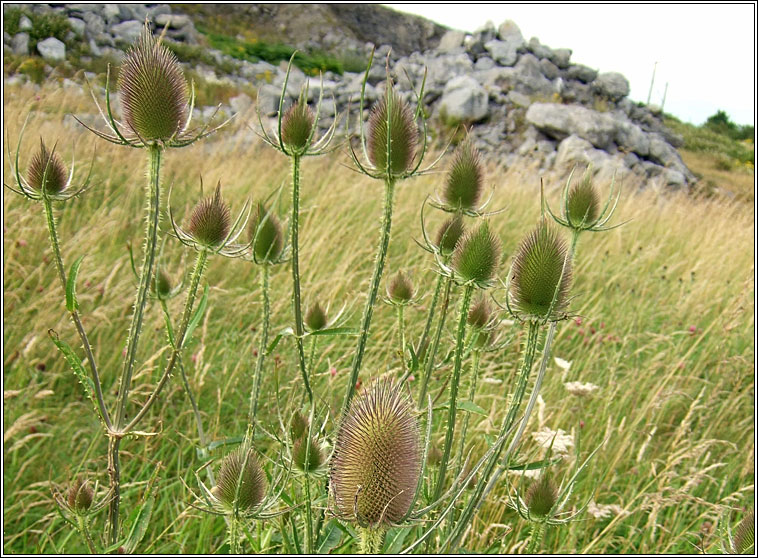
453 221 501 286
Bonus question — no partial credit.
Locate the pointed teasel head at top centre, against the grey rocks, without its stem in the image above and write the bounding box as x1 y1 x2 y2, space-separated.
366 85 418 175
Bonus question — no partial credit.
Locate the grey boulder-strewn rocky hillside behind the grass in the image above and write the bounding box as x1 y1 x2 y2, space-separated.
3 4 696 187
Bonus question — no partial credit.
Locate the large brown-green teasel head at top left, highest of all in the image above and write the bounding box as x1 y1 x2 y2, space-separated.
118 22 187 142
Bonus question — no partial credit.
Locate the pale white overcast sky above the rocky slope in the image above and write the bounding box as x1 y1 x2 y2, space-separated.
385 3 755 124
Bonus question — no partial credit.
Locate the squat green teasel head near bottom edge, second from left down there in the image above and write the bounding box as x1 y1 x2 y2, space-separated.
214 448 266 512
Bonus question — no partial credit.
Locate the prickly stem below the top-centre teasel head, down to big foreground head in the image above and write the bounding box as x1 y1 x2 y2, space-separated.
341 176 395 416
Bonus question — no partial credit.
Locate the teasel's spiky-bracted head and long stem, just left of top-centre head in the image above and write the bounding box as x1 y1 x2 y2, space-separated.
258 51 339 410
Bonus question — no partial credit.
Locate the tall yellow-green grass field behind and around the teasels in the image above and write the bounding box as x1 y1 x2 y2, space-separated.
3 80 755 553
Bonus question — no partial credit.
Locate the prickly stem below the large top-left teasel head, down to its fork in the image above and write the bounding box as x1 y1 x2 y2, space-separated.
113 143 163 428
